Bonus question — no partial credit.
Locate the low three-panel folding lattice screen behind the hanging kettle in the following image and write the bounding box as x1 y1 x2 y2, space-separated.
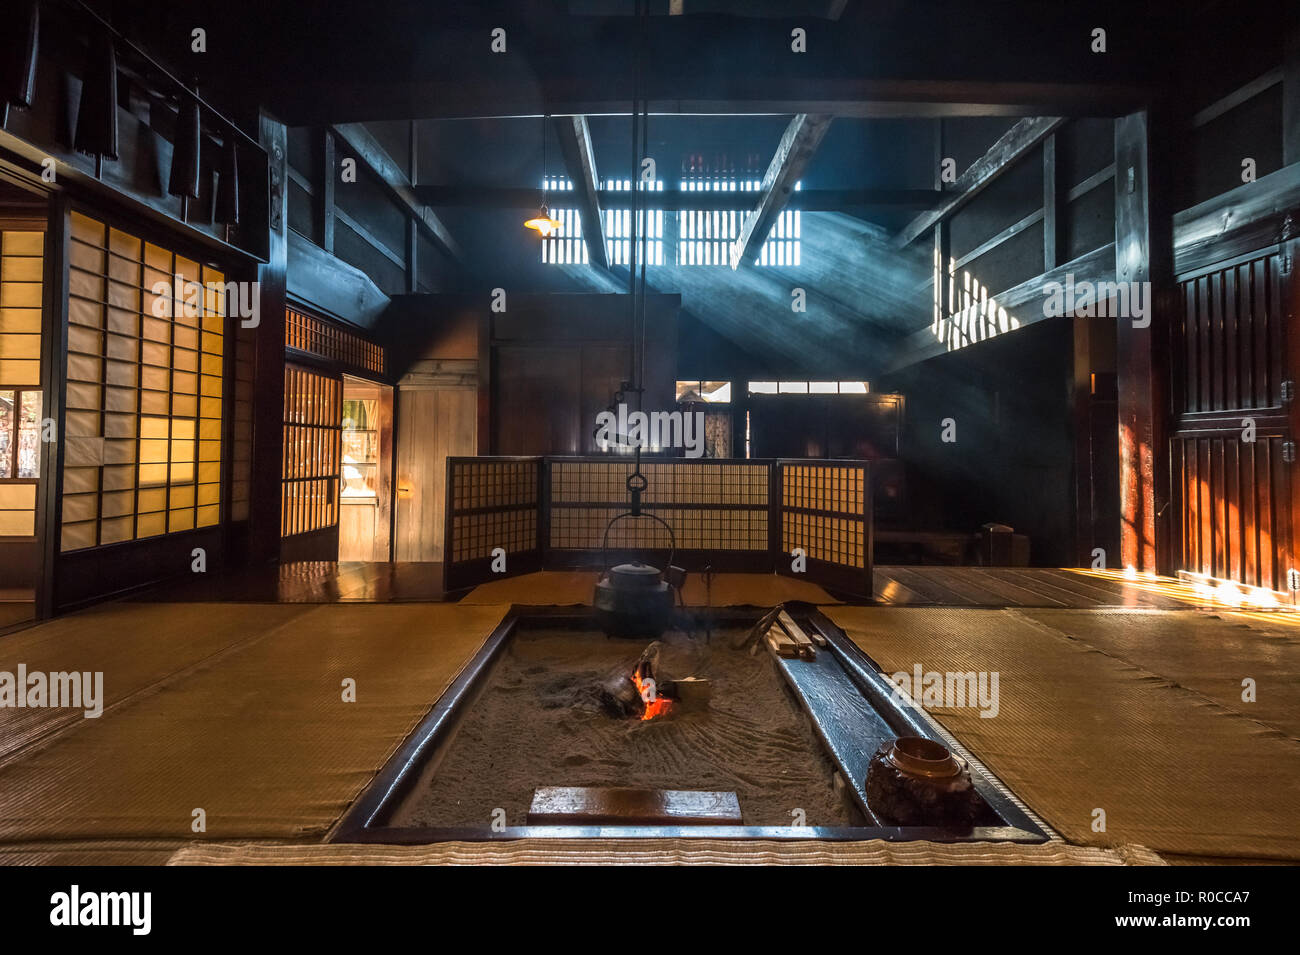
445 457 871 598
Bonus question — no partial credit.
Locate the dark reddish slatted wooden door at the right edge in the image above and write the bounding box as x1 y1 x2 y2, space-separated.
1170 240 1300 592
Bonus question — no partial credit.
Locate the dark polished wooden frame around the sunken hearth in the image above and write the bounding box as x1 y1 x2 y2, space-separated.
326 605 1050 845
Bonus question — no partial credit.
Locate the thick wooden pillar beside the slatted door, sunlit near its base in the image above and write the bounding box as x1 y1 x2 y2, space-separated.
1115 110 1175 573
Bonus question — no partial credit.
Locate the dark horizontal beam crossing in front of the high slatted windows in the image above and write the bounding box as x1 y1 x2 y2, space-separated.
415 186 943 210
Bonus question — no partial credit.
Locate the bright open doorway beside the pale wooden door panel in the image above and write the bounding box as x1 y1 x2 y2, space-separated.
338 376 393 561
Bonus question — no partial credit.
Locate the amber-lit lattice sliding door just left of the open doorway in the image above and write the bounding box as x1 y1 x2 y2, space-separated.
280 365 343 537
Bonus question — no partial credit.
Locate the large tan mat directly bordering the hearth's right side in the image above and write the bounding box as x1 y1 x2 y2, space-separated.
826 607 1300 859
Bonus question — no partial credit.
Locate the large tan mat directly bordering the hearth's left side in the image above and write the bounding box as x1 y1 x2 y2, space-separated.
0 604 504 842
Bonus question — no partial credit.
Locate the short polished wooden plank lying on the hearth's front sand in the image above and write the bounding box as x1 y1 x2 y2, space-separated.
528 786 742 825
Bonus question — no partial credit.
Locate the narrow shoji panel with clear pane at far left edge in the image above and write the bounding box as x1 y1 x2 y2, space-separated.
0 229 46 538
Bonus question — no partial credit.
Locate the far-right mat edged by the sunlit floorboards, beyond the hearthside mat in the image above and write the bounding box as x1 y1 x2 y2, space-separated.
1021 609 1300 743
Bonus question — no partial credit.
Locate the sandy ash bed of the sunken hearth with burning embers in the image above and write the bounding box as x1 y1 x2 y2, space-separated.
390 630 862 829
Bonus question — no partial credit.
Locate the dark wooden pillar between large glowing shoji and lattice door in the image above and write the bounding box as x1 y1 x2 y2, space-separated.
250 114 289 560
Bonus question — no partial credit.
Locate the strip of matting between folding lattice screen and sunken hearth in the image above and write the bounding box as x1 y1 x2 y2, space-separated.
460 570 837 607
